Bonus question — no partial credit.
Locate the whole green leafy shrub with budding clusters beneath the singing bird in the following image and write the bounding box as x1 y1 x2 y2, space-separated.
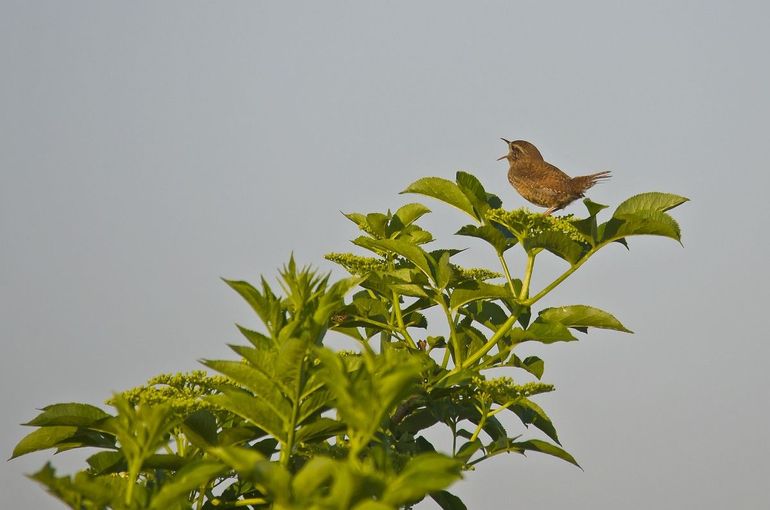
12 172 686 510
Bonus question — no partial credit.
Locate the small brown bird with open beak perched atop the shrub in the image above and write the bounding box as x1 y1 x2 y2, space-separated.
497 138 610 216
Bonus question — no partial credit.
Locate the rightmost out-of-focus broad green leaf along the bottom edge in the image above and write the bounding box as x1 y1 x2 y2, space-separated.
382 453 462 506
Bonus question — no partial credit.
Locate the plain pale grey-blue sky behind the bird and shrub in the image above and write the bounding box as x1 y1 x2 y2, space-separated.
0 0 770 510
